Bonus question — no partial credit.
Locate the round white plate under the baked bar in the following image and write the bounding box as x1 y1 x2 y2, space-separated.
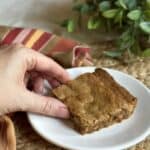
27 67 150 150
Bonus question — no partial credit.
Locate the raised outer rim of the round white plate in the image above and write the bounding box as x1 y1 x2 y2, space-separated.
27 66 150 150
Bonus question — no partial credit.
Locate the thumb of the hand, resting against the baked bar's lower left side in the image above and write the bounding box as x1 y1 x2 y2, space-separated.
22 91 69 118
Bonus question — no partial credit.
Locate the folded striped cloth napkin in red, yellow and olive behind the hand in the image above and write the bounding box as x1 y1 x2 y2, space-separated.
0 26 92 67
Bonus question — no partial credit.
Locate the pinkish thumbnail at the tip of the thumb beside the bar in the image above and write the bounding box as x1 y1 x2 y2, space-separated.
56 107 70 119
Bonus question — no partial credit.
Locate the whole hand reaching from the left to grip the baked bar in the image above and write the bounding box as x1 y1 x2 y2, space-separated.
0 45 69 118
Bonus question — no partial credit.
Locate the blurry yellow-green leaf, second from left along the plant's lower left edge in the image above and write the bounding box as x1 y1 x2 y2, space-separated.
87 17 100 30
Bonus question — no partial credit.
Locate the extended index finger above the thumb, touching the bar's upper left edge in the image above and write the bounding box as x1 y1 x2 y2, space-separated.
24 50 70 83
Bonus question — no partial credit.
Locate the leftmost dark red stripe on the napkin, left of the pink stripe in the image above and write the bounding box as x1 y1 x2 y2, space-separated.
2 28 23 44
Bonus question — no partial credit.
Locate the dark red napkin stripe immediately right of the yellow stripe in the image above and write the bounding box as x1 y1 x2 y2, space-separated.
32 32 52 50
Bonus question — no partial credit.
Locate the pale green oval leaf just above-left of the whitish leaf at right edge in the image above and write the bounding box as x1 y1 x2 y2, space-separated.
127 9 141 21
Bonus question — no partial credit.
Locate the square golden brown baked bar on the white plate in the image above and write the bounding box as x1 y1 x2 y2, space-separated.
52 68 137 134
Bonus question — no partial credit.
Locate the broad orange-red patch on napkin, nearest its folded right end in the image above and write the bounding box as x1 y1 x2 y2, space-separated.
51 38 77 53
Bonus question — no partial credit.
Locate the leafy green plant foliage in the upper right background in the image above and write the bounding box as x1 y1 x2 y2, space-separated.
63 0 150 57
